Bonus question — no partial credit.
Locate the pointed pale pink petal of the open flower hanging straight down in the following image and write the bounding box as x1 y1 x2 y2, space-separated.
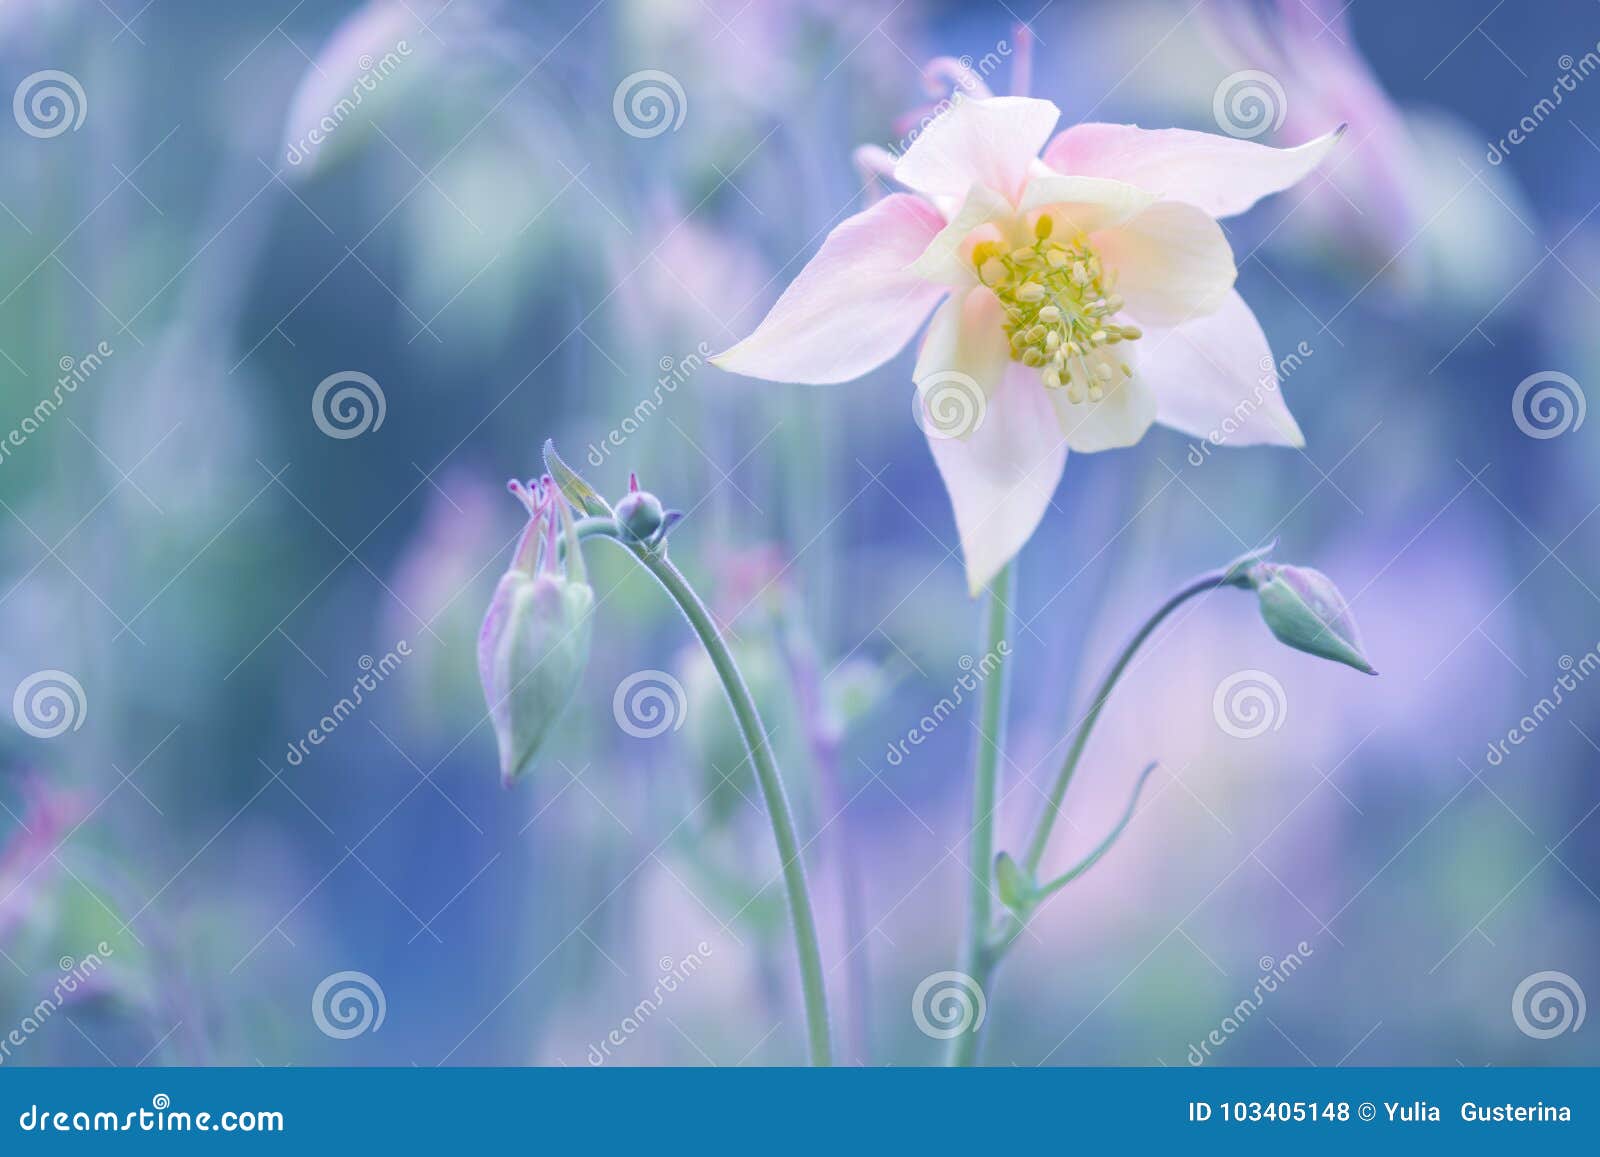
928 365 1067 595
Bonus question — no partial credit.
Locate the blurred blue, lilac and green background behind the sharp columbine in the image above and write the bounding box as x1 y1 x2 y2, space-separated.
0 0 1600 1066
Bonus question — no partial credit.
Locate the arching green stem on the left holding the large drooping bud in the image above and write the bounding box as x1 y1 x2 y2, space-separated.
576 518 834 1066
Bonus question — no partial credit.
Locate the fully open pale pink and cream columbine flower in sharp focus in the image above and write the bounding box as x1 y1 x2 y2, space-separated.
712 96 1342 594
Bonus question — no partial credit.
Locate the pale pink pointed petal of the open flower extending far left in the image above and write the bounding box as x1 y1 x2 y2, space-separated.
712 194 946 384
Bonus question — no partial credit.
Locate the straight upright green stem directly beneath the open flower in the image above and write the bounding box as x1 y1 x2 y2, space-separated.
946 563 1016 1066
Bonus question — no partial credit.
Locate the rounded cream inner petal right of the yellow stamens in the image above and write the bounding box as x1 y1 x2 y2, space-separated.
1091 202 1238 326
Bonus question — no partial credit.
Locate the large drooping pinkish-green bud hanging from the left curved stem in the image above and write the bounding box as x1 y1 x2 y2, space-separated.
478 477 595 786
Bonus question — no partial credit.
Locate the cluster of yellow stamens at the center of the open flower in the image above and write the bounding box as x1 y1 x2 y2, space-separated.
973 213 1142 405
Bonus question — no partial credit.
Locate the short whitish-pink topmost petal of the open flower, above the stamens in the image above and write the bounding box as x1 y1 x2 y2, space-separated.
894 96 1061 205
